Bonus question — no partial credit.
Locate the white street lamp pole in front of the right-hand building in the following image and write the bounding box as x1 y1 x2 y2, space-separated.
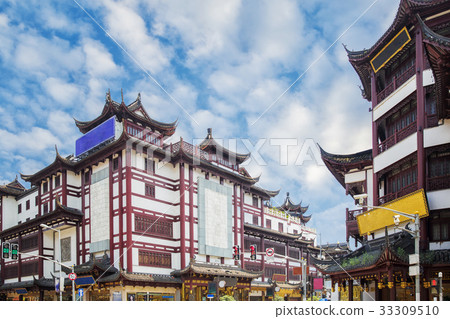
353 194 420 301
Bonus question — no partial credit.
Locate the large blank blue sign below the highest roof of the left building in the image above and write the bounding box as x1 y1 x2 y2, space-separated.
75 116 116 156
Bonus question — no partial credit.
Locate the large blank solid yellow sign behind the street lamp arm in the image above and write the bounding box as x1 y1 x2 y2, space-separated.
356 189 428 236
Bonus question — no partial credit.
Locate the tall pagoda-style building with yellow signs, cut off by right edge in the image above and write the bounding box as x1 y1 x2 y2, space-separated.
319 0 450 300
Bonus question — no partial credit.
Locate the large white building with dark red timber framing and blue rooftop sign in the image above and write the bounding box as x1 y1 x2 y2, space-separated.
0 93 316 300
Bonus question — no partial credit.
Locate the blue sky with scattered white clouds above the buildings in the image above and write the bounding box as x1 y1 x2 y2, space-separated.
0 0 399 248
